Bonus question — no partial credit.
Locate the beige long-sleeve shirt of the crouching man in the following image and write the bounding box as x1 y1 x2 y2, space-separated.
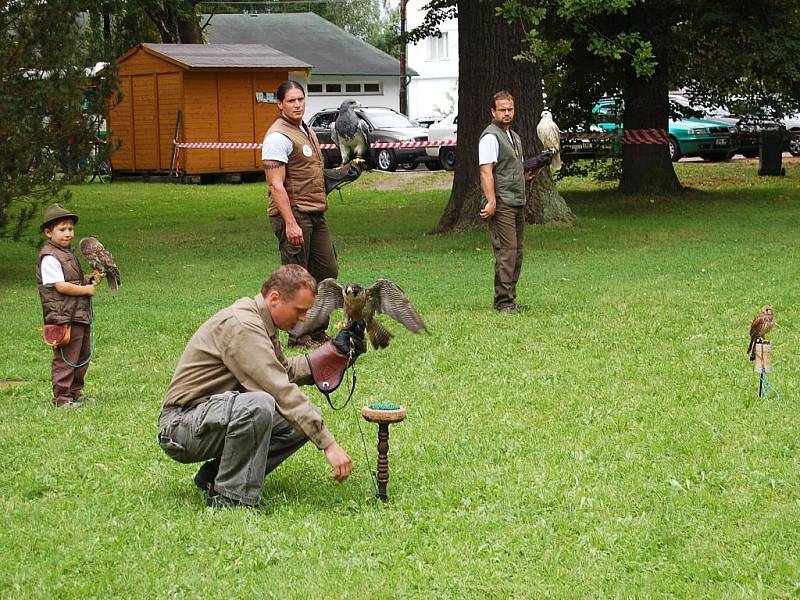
164 294 334 449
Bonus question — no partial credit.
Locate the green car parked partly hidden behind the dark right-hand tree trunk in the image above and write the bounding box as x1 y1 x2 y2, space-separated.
592 98 736 161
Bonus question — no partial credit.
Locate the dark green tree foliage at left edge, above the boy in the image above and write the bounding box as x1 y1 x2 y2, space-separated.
0 0 118 239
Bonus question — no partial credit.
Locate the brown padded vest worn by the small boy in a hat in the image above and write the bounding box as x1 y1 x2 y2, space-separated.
36 242 92 325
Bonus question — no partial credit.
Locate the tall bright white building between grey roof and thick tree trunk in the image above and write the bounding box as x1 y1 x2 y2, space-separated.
406 0 458 118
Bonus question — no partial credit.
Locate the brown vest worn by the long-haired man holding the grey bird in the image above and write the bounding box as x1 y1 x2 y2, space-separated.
267 115 328 216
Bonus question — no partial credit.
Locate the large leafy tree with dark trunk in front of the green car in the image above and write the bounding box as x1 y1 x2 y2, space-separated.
502 0 800 193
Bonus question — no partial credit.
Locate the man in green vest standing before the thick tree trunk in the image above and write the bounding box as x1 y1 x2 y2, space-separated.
478 91 533 314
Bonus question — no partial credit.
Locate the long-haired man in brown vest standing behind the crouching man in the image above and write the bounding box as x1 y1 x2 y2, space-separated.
261 81 339 347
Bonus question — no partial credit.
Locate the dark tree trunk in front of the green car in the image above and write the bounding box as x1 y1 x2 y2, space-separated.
619 7 682 194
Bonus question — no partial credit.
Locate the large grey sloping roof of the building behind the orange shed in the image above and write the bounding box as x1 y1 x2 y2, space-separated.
202 13 416 75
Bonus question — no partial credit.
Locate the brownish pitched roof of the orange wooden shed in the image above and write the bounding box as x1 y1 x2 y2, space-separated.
126 44 311 69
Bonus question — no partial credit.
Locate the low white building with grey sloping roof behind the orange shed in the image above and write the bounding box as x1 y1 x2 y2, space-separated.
202 13 416 121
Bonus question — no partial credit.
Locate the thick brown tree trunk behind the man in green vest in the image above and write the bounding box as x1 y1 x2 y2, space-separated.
435 0 574 232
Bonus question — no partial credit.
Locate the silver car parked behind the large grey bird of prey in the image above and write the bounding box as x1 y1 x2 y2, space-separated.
308 106 428 171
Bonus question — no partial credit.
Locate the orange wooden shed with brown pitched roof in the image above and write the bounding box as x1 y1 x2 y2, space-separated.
108 44 311 175
